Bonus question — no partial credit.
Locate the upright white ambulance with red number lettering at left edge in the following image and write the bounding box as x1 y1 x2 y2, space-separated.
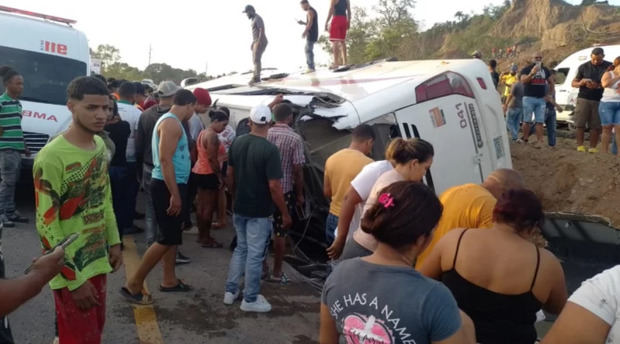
0 6 90 166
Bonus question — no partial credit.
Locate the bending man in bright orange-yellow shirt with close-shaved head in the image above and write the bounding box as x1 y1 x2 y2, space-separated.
416 169 524 268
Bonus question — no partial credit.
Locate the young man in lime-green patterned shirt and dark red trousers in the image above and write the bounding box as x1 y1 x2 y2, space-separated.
33 77 123 344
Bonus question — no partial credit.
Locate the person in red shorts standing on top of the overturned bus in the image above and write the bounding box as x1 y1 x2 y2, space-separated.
325 0 351 69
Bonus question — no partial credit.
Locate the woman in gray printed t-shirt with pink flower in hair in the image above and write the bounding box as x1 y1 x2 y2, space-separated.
320 181 474 344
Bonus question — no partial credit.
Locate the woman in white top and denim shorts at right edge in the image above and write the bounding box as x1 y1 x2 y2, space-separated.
598 57 620 153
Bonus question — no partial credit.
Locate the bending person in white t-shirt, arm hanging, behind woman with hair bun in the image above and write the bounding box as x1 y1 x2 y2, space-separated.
327 160 393 259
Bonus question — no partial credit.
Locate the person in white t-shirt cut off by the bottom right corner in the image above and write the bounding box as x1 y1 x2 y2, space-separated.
542 265 620 344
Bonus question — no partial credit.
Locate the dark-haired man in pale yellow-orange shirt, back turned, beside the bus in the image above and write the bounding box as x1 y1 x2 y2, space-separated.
323 124 375 245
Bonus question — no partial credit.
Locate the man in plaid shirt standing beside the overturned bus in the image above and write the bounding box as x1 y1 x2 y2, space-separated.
267 103 306 284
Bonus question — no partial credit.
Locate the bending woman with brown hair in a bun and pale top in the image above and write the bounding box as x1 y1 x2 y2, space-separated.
341 138 435 260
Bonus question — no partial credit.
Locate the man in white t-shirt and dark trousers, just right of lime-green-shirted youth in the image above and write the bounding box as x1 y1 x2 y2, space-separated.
118 81 142 234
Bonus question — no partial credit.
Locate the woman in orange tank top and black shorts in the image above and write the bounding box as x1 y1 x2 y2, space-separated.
192 111 228 248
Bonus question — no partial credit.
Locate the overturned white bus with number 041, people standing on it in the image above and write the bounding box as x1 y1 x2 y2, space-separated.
188 59 512 194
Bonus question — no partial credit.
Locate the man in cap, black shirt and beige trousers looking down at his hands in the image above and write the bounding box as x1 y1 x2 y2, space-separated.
572 48 612 153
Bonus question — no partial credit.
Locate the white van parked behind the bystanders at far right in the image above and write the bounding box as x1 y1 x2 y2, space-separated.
555 45 620 124
